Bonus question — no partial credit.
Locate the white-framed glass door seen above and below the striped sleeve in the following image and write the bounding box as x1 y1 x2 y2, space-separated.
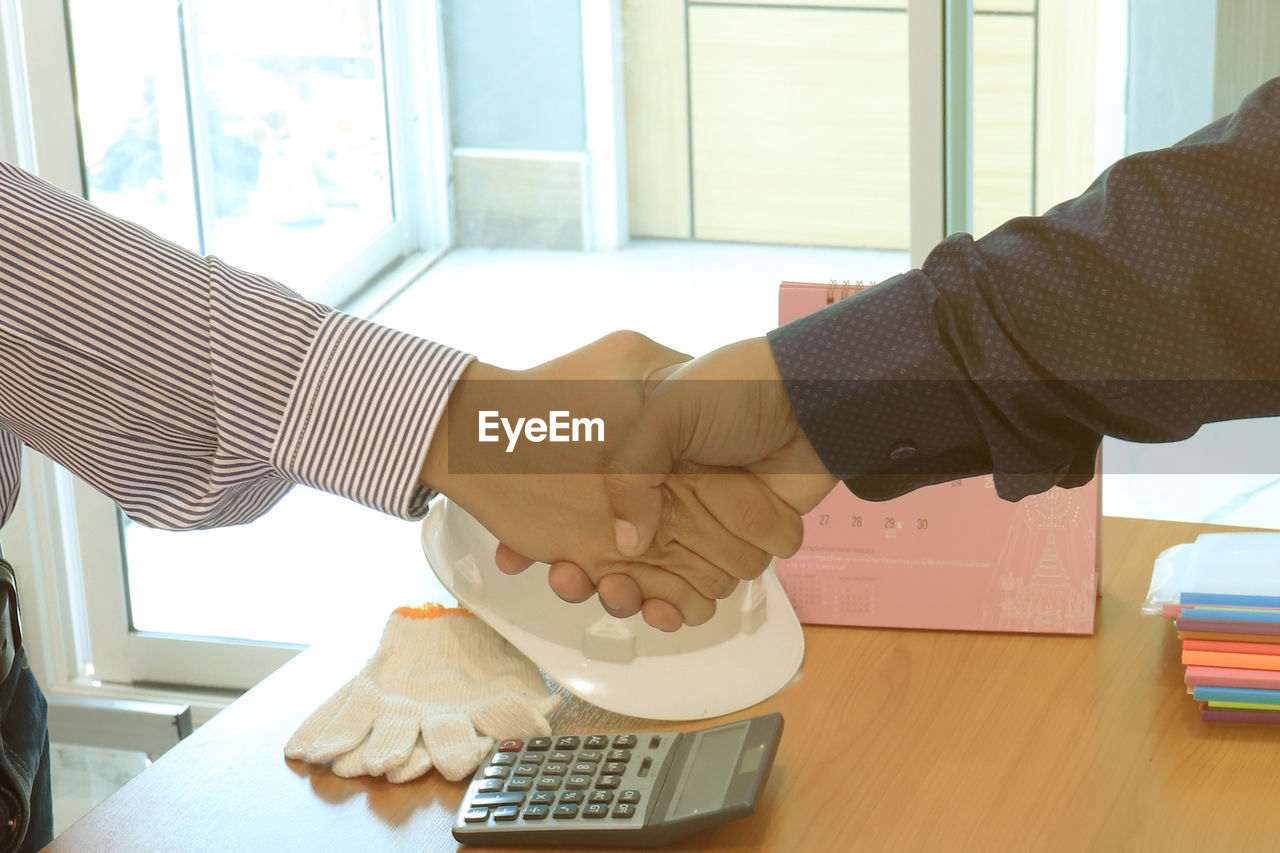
23 0 451 688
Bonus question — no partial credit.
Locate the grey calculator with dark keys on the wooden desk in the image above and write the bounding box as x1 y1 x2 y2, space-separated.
453 713 782 847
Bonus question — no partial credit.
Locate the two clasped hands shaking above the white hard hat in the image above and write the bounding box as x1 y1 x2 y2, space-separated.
419 332 836 631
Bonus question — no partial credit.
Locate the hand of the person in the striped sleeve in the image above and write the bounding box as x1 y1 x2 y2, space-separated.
421 333 800 630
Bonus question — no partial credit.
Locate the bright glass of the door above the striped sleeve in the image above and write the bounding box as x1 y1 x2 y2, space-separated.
69 0 407 302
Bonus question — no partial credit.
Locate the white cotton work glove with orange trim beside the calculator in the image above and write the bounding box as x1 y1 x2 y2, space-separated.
284 605 561 783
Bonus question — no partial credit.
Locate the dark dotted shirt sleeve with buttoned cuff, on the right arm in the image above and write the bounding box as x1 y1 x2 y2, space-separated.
769 78 1280 500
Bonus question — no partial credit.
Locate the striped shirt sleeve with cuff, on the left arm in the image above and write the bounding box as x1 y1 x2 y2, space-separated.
0 163 470 529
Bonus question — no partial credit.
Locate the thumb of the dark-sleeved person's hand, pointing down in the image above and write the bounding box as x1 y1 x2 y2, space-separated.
604 386 684 557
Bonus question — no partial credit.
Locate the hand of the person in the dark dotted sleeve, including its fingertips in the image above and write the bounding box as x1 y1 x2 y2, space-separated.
537 338 837 622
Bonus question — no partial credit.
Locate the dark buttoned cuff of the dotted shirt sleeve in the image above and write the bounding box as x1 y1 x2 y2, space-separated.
769 270 992 501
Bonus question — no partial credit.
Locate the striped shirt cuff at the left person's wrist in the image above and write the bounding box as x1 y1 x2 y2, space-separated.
271 311 472 520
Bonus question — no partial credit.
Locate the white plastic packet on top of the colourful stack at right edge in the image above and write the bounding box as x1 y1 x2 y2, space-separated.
1142 533 1280 616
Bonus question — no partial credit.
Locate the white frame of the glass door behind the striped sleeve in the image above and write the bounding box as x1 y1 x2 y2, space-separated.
0 0 452 691
